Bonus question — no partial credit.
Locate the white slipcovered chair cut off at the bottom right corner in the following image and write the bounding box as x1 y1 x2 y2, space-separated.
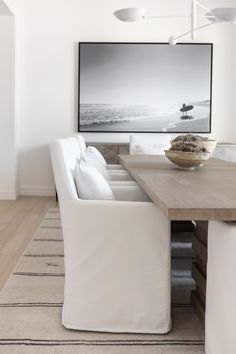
206 221 236 354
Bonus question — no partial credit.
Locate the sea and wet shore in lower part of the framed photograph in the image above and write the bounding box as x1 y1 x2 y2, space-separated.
80 100 210 133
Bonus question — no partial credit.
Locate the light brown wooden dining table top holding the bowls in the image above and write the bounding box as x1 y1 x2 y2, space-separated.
119 155 236 221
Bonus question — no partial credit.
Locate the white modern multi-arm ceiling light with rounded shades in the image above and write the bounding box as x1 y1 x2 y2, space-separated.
113 0 236 45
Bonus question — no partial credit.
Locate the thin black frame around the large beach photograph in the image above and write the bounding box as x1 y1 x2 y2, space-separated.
78 42 213 134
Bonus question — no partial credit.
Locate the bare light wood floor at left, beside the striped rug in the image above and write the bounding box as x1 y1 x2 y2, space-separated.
0 197 58 290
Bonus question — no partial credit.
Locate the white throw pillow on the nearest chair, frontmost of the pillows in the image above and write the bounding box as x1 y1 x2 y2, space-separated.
75 161 115 200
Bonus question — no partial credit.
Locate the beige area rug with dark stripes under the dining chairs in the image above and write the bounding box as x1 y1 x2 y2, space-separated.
0 209 204 354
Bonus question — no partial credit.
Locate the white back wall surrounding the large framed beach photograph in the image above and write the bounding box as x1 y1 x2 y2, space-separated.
3 0 236 194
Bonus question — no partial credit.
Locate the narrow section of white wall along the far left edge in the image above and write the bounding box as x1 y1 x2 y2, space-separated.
0 14 16 199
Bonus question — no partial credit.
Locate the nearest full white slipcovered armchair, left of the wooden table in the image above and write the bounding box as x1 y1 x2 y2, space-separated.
50 138 171 333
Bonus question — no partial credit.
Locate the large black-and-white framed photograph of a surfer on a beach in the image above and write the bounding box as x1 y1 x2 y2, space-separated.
78 42 213 133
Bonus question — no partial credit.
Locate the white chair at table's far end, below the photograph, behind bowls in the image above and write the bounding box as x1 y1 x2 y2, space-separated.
129 134 171 155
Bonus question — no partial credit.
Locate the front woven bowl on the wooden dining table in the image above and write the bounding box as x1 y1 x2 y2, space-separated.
165 150 211 169
